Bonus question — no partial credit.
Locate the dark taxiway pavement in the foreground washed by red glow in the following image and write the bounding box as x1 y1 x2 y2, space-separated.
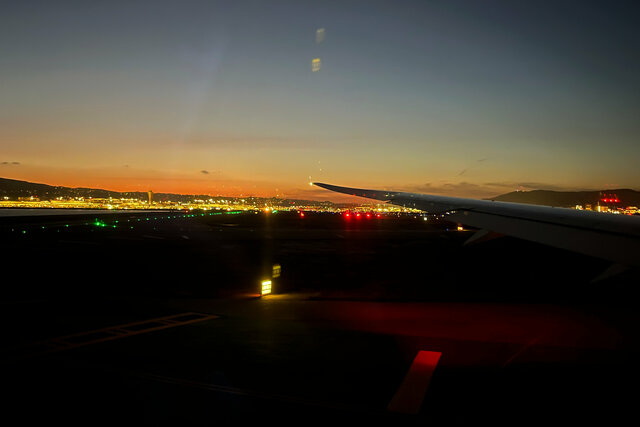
2 295 637 424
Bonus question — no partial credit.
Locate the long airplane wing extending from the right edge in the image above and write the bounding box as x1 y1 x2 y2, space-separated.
313 182 640 266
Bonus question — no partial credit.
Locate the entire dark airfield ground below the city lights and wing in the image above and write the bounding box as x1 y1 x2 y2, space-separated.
0 213 640 425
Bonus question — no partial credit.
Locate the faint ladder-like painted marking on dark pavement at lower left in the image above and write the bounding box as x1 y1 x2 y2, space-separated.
29 312 218 353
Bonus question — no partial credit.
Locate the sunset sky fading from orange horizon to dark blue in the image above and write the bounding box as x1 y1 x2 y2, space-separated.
0 0 640 200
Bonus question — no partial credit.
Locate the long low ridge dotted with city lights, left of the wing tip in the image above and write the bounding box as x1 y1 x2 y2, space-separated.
0 178 335 206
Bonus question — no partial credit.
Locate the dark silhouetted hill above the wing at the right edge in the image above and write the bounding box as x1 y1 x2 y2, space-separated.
491 189 640 207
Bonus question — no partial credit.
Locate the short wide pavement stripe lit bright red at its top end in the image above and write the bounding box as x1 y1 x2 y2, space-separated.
387 350 442 415
